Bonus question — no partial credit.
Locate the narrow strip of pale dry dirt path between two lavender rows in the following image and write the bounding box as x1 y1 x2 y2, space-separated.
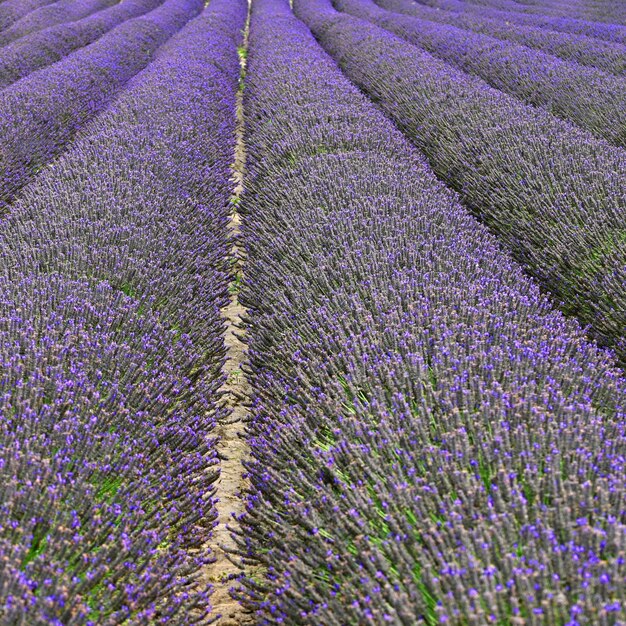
201 17 254 626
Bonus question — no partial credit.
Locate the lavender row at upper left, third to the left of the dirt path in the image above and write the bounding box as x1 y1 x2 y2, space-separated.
0 0 163 90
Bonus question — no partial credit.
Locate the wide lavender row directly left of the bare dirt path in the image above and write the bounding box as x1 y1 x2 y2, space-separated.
0 0 247 626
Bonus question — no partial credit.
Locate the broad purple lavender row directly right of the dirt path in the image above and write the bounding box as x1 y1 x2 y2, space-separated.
234 0 626 626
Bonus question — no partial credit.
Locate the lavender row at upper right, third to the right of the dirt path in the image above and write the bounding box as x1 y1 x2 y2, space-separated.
334 0 626 148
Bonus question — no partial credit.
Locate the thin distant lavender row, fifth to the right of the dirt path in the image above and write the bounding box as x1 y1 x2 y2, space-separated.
415 0 626 45
